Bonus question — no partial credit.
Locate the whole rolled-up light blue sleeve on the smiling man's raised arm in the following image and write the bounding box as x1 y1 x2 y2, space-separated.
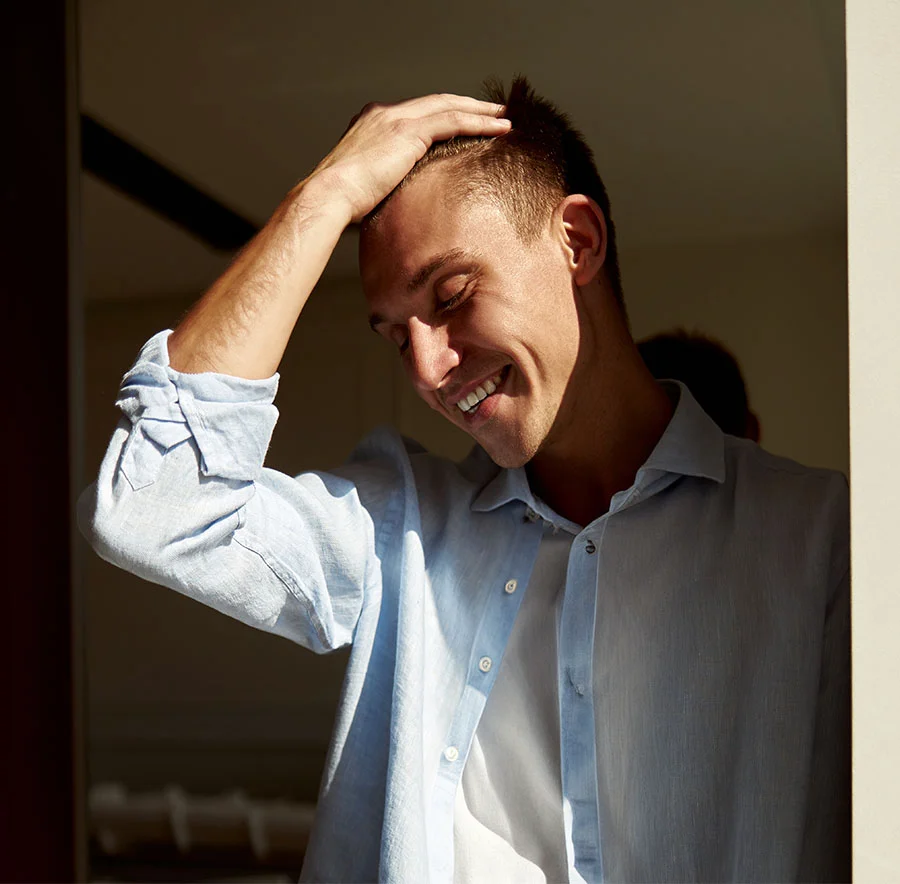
78 332 378 652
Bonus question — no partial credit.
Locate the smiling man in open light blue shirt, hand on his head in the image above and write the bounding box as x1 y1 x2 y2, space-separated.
83 80 849 882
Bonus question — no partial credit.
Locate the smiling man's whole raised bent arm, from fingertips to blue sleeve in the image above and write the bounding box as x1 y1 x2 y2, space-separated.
79 95 509 650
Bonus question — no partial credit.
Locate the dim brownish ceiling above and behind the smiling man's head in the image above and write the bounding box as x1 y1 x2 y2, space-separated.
80 0 846 298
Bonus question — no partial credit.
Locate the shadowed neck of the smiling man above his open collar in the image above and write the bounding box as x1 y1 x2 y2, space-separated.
527 314 673 525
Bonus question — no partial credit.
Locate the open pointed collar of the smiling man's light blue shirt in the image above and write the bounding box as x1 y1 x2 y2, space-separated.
463 381 725 513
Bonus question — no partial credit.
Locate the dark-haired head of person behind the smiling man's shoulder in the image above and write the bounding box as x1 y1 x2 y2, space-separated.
637 329 761 442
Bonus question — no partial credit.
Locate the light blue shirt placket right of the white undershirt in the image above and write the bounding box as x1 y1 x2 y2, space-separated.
558 518 606 884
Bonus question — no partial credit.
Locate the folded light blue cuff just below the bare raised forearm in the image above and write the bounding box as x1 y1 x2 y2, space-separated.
116 329 278 481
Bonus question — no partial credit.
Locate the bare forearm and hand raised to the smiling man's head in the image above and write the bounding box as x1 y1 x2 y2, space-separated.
168 95 510 378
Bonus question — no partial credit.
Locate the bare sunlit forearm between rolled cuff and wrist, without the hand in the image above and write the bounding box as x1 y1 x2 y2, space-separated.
169 176 350 379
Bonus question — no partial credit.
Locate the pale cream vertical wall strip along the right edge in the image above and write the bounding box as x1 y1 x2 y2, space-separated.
847 0 900 884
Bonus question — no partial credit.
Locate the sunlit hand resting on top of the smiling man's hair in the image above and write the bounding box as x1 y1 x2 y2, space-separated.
307 95 510 221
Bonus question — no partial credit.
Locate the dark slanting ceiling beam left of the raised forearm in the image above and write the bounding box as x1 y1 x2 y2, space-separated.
81 114 259 252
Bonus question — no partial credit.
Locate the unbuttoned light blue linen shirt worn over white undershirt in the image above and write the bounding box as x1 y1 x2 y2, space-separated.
79 332 850 882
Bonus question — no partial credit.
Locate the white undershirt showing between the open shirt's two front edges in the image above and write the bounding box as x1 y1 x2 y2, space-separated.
453 527 573 884
